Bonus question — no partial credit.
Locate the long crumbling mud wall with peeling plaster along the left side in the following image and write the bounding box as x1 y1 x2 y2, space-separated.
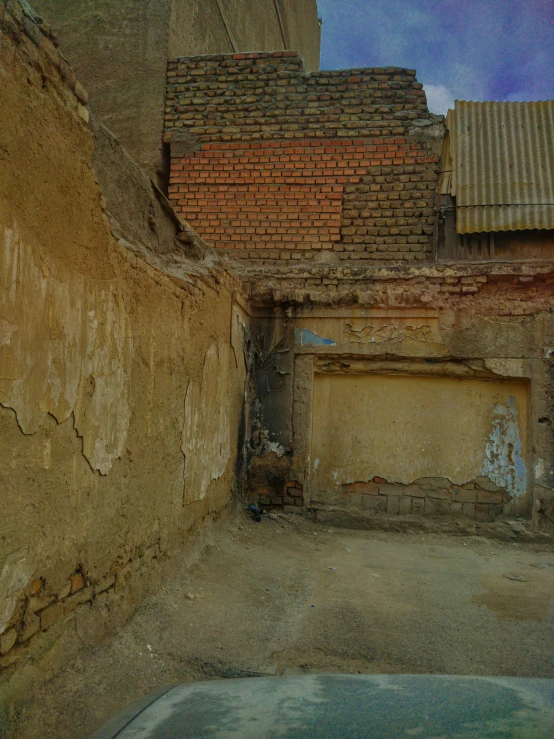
0 2 245 716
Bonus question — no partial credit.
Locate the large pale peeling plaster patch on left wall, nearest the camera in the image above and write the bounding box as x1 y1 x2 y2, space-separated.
0 228 133 475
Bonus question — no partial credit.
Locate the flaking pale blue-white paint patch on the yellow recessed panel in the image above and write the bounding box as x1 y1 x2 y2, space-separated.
483 396 527 497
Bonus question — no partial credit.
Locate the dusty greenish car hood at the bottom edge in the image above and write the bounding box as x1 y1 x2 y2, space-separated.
92 675 554 739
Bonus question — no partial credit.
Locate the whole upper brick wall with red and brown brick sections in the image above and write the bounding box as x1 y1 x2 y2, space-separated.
165 52 437 261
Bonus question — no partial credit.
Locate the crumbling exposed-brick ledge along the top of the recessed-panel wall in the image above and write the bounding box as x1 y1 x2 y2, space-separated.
243 260 554 312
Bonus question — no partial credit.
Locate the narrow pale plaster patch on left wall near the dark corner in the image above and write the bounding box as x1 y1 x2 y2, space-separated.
181 344 234 504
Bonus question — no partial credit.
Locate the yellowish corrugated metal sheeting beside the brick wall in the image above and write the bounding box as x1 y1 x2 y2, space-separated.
447 100 554 234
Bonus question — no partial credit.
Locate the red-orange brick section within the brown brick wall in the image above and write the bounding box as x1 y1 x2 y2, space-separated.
170 140 350 249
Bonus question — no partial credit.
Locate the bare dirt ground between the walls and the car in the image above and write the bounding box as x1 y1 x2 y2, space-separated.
11 514 554 739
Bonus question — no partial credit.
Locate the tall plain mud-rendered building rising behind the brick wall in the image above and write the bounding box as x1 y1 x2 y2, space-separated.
32 0 320 185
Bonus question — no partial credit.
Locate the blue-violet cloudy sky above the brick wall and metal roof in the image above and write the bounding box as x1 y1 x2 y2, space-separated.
318 0 554 114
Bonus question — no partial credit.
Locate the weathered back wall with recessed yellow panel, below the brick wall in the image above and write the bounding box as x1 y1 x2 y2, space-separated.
244 262 554 528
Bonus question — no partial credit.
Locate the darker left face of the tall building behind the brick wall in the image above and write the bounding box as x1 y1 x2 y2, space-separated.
32 0 171 182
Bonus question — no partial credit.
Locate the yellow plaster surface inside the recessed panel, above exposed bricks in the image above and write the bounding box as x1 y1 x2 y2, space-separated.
311 374 528 496
